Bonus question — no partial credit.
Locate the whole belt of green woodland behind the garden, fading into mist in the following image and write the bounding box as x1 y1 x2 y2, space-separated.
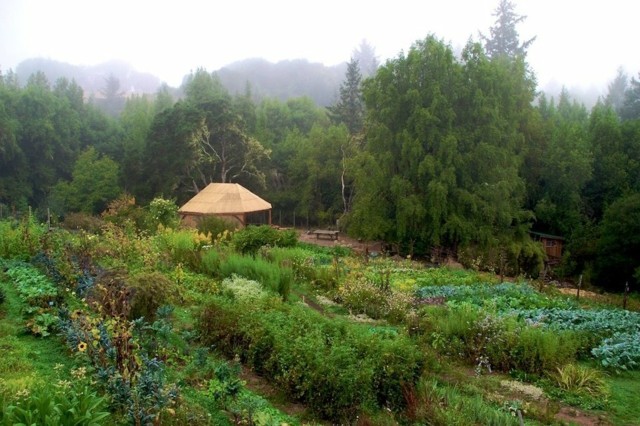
0 1 640 289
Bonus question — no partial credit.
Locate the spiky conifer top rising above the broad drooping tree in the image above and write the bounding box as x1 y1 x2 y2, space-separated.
480 0 535 58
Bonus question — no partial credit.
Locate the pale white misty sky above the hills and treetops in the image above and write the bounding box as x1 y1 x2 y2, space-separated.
0 0 640 90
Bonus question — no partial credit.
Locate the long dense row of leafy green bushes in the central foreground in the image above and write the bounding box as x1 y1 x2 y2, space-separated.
198 297 424 423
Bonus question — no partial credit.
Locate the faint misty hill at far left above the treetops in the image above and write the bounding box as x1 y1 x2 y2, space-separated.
16 58 161 97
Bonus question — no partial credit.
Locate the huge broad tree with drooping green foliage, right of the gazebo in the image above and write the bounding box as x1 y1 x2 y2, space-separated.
349 36 535 252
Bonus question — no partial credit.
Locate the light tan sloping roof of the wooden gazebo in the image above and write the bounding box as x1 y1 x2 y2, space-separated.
178 183 271 215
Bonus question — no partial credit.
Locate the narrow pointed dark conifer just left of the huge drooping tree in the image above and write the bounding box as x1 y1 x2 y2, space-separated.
328 58 364 135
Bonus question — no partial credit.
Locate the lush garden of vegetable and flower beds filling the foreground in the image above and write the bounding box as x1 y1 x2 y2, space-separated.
0 204 640 425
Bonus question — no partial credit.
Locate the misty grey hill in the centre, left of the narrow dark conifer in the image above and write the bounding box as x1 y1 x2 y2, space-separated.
217 59 347 106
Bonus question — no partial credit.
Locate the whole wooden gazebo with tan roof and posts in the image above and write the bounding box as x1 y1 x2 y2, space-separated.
178 183 271 227
